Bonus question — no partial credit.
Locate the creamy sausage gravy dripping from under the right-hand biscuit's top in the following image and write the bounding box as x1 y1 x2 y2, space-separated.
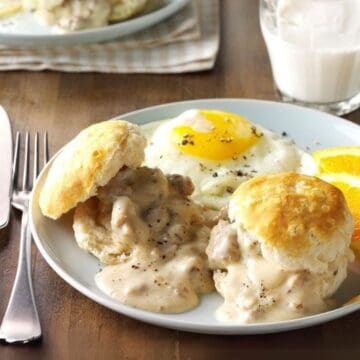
206 221 348 323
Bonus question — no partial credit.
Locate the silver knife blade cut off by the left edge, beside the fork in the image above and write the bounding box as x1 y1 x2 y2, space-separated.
0 106 13 229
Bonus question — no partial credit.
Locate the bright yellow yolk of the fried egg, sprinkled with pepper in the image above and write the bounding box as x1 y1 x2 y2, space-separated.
171 110 263 160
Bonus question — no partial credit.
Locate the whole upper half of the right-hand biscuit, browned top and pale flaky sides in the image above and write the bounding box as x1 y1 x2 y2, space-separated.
229 173 353 272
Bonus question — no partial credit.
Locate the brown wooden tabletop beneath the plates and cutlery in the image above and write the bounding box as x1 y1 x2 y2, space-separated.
0 0 360 360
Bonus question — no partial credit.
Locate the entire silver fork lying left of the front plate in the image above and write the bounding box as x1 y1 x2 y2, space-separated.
0 132 48 343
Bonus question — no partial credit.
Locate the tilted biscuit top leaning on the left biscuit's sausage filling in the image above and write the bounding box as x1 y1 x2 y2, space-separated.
39 120 146 219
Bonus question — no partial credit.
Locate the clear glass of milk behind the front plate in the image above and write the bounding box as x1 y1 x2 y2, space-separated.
260 0 360 115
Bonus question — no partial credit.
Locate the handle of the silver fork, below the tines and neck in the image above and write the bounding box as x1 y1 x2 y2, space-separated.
0 211 41 342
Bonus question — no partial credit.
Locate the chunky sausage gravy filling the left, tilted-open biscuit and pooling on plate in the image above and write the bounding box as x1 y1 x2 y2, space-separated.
78 168 214 313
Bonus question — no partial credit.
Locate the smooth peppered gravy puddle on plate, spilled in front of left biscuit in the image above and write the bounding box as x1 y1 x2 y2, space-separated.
95 240 214 313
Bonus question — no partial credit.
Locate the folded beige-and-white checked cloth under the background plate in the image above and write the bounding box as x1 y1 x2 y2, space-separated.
0 0 220 73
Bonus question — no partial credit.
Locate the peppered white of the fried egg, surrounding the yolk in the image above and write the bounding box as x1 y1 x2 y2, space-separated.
143 110 316 209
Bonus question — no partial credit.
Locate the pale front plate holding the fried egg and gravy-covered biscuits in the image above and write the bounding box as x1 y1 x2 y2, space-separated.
31 99 360 334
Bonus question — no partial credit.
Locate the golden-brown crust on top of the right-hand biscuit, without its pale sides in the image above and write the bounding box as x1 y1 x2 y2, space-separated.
229 172 348 256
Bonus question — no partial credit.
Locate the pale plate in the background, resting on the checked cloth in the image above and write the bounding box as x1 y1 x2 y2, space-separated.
0 0 189 46
